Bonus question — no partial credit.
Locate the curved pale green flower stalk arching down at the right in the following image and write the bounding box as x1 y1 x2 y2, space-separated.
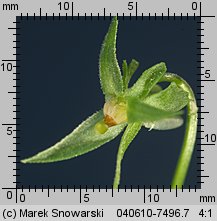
160 73 198 189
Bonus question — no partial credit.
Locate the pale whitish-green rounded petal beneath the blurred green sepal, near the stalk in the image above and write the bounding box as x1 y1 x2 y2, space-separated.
143 116 184 130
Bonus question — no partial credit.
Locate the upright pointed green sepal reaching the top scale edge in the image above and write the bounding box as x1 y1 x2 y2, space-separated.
99 17 123 97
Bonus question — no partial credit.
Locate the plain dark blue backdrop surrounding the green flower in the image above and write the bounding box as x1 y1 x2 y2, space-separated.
17 17 199 187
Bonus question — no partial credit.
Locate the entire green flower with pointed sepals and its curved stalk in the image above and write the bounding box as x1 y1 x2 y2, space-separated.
21 17 197 188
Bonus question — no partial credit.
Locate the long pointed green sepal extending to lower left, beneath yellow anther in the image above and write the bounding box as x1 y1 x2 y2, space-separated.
21 111 126 163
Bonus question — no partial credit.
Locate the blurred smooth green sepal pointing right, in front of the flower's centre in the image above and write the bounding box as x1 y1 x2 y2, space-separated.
127 98 181 123
